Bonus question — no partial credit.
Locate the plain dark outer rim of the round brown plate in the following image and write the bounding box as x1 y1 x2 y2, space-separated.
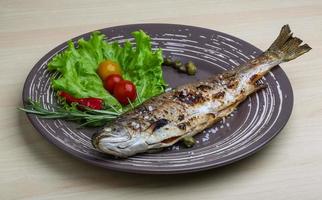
22 23 294 174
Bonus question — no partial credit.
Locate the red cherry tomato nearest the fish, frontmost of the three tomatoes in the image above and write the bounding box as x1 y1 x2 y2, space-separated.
113 80 136 105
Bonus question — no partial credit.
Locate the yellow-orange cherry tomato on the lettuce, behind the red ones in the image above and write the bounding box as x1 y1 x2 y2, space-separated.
97 60 121 81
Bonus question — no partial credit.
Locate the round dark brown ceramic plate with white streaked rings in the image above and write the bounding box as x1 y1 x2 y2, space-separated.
23 24 293 174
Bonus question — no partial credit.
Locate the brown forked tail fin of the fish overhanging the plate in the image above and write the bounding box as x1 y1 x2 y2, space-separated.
265 24 312 62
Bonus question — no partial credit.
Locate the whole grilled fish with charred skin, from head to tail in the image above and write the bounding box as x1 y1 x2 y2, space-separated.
92 25 311 157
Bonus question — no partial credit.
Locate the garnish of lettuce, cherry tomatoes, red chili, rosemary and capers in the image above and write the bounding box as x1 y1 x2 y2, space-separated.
21 30 196 126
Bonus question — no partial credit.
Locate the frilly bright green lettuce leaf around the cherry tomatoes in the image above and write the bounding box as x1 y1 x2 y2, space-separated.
48 30 166 109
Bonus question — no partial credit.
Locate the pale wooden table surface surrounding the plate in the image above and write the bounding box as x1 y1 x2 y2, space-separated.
0 0 322 200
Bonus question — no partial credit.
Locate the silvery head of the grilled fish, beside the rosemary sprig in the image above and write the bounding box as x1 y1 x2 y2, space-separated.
92 124 149 158
